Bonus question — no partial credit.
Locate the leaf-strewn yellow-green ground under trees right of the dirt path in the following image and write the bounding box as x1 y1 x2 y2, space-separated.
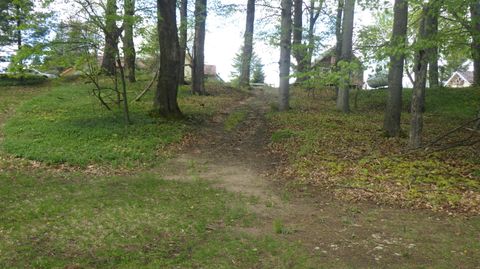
269 89 480 213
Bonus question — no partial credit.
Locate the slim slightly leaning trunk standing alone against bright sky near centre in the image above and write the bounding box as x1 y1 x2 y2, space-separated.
239 0 255 87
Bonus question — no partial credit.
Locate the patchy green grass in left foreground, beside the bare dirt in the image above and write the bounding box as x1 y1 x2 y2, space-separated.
0 173 316 268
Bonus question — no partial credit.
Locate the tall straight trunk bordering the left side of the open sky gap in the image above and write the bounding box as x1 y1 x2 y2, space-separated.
192 0 207 95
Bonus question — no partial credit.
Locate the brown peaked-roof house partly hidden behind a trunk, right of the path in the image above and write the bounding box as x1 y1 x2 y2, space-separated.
313 46 364 89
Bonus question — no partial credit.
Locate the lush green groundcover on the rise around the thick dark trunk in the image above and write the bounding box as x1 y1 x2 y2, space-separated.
0 79 241 167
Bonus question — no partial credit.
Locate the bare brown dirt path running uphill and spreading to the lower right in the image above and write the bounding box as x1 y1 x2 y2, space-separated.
162 91 480 268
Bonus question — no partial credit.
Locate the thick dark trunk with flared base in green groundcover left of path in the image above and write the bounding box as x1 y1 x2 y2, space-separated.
154 0 182 115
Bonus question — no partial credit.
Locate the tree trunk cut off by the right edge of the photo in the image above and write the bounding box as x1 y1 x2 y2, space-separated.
470 0 480 86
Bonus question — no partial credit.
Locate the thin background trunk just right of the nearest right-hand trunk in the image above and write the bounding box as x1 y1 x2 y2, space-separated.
425 1 442 88
